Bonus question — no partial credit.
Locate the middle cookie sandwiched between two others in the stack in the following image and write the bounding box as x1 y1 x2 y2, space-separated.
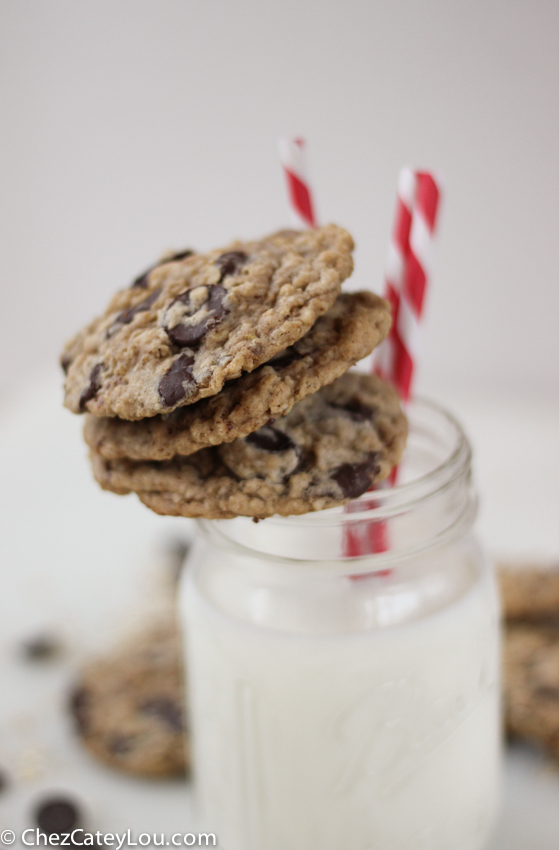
84 292 390 460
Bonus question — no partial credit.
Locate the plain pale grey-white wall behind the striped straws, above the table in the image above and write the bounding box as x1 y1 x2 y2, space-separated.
0 0 559 393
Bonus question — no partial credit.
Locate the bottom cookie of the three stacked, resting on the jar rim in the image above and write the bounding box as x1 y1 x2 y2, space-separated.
91 372 407 519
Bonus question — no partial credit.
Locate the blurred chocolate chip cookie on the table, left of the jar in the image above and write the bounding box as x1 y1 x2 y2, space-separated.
70 617 189 777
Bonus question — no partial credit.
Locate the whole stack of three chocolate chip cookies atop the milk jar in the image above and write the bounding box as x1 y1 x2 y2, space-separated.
61 225 407 519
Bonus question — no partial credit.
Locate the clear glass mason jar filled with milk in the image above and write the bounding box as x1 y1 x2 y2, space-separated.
180 401 500 850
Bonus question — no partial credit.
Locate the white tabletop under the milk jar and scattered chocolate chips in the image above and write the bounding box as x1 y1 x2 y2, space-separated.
0 374 559 850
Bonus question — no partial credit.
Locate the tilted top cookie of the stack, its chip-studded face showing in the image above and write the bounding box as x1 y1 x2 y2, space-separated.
61 225 353 419
